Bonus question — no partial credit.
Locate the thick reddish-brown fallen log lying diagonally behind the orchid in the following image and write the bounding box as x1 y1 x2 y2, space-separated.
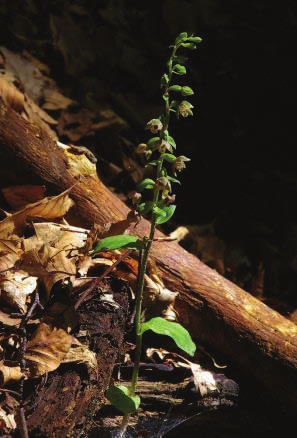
0 97 297 413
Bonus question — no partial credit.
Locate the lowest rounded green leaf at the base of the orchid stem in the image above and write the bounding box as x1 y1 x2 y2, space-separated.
106 385 140 416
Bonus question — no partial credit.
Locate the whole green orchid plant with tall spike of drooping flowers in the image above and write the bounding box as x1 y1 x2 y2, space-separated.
93 32 201 432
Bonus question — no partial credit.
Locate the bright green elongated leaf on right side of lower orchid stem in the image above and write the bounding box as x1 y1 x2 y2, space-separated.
140 317 196 356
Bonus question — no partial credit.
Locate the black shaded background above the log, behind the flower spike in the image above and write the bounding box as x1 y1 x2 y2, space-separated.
0 0 297 310
